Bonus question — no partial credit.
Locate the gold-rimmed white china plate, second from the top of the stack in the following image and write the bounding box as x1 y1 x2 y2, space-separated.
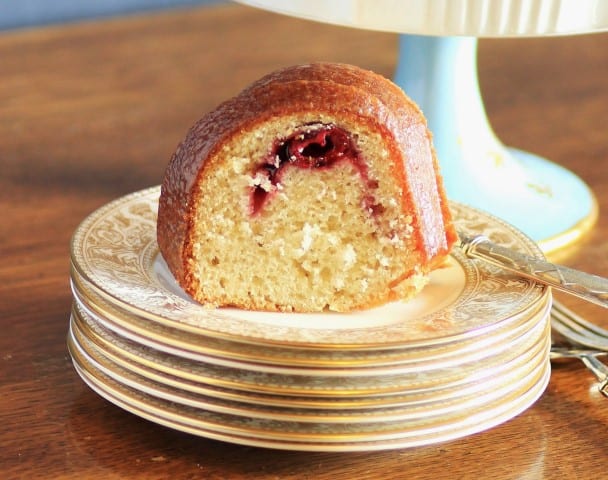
71 264 551 373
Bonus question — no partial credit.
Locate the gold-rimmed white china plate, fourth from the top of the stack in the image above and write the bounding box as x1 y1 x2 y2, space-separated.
72 305 549 398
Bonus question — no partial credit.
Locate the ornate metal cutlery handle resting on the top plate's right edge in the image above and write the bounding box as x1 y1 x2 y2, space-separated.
460 235 608 308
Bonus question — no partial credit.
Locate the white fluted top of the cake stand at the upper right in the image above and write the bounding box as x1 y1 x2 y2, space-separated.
239 0 608 37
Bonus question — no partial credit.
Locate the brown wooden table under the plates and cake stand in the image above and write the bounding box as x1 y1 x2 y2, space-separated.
0 5 608 480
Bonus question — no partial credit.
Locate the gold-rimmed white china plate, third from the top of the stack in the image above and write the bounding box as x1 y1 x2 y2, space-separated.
74 288 551 379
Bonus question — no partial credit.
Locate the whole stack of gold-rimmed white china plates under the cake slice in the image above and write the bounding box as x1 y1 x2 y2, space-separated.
68 187 551 451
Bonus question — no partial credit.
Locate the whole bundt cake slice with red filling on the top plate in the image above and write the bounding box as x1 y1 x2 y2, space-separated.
157 63 456 312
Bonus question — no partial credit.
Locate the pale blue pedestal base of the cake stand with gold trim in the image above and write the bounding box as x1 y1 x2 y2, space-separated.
395 35 598 257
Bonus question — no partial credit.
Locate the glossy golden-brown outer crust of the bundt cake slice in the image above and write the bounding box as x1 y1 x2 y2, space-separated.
157 63 455 308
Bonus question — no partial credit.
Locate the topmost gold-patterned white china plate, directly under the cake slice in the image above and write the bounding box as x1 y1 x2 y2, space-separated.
71 187 550 349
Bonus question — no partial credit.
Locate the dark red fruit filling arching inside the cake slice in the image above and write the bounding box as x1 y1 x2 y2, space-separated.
251 123 378 215
